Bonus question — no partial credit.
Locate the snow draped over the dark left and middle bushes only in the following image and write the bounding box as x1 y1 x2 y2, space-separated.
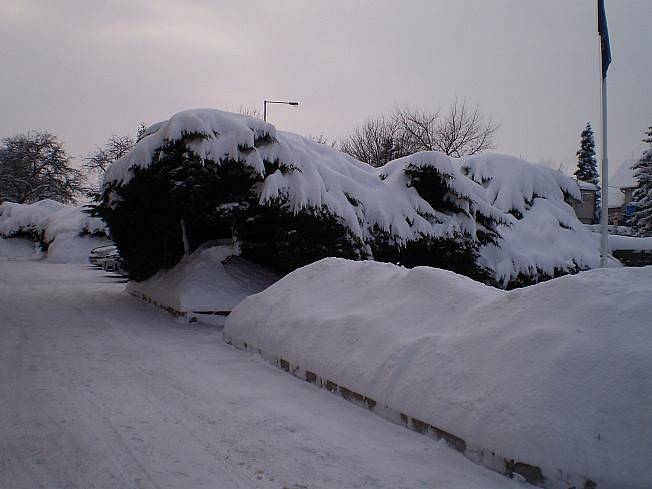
104 109 500 248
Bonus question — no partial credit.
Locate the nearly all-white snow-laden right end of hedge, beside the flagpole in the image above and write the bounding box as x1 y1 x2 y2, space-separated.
456 154 600 285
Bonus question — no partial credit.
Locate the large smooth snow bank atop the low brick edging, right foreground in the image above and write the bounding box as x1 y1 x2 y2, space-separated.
224 258 652 488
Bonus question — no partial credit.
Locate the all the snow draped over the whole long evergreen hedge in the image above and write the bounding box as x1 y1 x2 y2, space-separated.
104 109 599 284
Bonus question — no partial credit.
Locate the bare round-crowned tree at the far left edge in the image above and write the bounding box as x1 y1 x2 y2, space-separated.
0 131 84 204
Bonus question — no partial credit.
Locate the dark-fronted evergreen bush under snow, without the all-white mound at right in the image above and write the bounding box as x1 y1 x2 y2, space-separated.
98 109 500 280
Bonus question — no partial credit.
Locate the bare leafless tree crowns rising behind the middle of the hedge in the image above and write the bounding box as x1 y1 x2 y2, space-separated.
340 100 499 166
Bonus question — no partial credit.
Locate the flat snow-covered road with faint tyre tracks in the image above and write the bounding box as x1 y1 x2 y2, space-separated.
0 258 524 489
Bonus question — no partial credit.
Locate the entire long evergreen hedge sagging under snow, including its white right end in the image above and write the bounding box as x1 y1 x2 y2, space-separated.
98 109 597 286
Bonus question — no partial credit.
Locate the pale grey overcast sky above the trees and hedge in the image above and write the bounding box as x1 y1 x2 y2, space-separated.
0 0 652 172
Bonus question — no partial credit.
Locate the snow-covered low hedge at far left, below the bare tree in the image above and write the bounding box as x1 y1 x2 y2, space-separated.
0 199 108 263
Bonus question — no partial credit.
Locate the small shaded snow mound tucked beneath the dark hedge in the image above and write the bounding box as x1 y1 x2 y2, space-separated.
127 243 280 317
